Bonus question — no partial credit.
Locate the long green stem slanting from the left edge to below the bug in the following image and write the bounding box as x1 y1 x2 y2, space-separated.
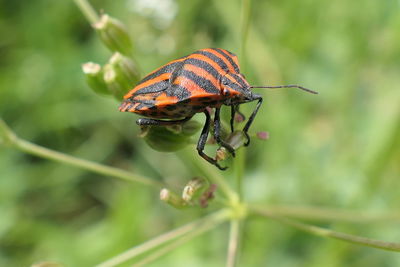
0 119 165 188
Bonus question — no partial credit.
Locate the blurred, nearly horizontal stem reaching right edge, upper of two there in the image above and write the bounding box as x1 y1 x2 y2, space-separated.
250 205 400 223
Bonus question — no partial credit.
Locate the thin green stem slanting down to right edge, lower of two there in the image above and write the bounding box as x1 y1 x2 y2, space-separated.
251 207 400 252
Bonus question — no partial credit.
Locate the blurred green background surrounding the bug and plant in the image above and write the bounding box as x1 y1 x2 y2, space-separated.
0 0 400 266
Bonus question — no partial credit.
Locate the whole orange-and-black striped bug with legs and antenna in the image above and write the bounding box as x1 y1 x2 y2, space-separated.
119 48 316 170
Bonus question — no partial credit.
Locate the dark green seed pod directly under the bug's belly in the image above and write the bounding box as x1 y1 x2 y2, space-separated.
140 121 201 152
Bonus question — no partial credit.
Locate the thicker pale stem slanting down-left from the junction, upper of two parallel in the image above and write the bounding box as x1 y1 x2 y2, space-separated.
97 209 230 267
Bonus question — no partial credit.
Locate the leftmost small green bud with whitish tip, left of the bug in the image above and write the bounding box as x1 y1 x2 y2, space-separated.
82 62 111 95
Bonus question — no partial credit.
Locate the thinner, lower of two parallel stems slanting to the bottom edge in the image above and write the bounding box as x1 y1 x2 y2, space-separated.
132 219 223 267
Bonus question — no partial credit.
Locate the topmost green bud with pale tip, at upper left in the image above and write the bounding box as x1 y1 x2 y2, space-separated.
93 14 132 55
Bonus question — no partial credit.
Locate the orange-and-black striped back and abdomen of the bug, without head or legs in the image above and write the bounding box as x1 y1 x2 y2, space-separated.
120 48 244 118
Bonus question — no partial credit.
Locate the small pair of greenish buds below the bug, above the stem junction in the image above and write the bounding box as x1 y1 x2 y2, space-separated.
160 177 217 209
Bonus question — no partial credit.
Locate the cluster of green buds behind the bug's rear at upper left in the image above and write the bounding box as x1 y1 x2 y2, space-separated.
82 14 140 100
